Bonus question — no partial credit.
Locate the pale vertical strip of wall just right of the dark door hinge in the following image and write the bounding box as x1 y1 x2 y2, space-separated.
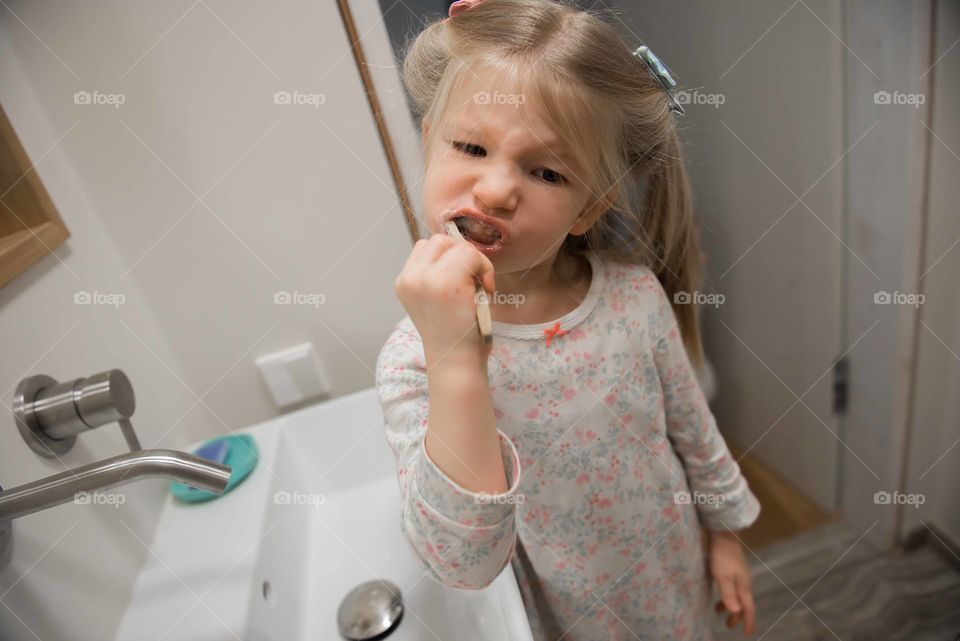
841 0 946 546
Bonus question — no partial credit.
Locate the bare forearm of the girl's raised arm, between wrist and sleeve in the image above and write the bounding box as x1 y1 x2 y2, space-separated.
425 362 509 494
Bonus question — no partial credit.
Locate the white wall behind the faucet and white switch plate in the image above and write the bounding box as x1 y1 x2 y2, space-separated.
0 0 410 640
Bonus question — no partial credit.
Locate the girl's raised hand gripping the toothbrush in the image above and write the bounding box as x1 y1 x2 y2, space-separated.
394 234 494 370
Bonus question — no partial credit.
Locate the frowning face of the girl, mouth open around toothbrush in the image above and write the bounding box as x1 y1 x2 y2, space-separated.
423 70 599 273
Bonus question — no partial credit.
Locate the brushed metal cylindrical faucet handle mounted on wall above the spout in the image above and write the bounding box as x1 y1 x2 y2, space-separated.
13 369 139 458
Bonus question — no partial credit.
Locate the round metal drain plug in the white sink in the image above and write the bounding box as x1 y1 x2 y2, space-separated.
337 579 403 641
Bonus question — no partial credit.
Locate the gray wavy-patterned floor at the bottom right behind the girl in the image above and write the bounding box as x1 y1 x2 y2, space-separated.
716 524 960 641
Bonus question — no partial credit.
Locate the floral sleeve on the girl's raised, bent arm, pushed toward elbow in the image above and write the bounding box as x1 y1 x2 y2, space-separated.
375 319 520 589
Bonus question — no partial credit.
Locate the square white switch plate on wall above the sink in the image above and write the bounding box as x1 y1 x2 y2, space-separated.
255 343 330 408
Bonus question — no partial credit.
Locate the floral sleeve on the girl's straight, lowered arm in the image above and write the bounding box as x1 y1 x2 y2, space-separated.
651 272 760 530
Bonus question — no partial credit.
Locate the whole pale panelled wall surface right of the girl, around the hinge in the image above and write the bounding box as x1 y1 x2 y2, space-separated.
618 0 960 545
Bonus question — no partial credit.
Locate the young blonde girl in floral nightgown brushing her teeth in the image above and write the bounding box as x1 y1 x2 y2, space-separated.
376 0 760 641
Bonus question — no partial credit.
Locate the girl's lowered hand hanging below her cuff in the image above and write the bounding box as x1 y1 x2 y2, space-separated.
710 530 757 635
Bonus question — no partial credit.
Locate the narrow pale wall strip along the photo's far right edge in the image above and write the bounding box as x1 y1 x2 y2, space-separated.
901 2 960 544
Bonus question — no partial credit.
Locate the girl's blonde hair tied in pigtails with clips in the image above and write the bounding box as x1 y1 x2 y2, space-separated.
403 0 703 367
